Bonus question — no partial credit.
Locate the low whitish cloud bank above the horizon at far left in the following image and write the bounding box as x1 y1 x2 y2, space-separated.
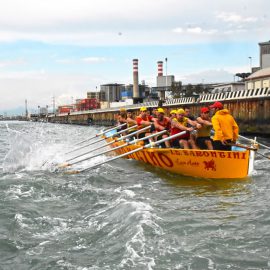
0 70 117 114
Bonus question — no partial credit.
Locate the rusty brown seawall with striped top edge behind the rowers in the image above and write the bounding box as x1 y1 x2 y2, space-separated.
48 88 270 136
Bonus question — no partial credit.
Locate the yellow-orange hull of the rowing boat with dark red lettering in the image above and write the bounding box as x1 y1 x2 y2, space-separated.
108 139 254 178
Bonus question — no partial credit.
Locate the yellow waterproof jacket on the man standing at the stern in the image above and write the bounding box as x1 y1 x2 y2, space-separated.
212 109 239 141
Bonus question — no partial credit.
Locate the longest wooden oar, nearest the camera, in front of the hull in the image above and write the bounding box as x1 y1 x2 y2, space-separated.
65 131 186 174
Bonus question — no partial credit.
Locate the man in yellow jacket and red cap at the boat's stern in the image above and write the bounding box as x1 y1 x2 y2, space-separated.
210 101 239 151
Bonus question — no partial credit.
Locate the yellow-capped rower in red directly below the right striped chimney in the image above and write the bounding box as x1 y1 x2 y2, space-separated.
152 108 171 148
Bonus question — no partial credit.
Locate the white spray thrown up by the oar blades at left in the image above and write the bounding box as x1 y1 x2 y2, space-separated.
3 123 104 173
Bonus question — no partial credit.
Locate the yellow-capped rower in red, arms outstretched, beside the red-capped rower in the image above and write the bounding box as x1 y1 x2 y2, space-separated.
171 109 201 149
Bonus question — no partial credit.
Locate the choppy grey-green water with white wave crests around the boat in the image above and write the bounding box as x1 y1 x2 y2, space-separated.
0 122 270 270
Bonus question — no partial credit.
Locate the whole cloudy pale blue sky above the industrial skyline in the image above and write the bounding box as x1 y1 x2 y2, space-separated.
0 0 270 114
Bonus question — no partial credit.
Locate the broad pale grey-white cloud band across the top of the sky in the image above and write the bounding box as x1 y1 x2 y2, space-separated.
0 0 270 46
